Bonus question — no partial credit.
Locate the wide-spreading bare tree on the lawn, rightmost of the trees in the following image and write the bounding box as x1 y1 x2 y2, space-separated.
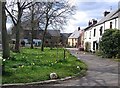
37 0 75 51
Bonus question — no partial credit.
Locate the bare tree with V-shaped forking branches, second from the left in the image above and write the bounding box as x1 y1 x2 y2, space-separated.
5 0 32 52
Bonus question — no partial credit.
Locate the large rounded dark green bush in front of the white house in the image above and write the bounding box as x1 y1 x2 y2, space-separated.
100 29 120 58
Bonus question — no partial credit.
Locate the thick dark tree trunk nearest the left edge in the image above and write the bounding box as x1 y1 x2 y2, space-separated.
2 2 10 59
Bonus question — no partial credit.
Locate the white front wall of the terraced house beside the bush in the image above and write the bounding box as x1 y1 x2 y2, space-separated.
84 18 119 51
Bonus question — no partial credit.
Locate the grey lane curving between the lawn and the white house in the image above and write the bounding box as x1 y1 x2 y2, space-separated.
48 48 118 86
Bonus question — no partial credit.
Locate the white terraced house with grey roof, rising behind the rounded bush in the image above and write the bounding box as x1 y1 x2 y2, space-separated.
84 10 120 51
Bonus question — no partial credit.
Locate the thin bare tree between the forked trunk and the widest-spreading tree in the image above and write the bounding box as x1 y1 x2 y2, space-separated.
22 2 39 49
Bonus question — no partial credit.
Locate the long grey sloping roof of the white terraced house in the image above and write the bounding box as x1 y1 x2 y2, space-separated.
94 9 120 26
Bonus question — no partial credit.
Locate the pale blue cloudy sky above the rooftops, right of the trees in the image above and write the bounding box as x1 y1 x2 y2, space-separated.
61 0 120 33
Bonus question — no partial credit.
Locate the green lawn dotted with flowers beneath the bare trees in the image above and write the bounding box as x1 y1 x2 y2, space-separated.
2 48 87 84
